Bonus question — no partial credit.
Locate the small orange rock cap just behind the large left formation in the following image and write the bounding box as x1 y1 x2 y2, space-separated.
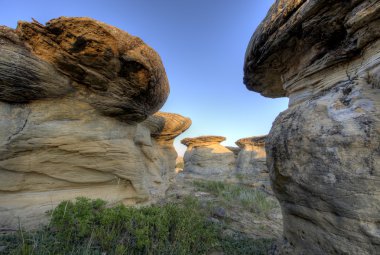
144 112 191 141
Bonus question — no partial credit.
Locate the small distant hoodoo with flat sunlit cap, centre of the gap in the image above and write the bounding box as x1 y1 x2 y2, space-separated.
181 136 235 179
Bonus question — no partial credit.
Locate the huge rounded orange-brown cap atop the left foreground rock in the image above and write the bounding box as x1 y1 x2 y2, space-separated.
0 17 169 121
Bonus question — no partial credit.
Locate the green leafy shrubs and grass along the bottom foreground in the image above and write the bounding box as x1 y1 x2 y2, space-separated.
0 198 273 255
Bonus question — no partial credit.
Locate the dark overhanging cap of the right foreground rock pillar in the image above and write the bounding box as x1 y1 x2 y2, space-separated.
244 0 380 97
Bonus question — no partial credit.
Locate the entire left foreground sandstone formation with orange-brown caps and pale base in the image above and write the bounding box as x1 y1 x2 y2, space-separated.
0 18 191 228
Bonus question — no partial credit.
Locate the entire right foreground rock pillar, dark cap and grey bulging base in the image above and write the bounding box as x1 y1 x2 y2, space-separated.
244 0 380 255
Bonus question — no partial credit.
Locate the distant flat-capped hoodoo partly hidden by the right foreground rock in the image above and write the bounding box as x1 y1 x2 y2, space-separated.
236 136 270 189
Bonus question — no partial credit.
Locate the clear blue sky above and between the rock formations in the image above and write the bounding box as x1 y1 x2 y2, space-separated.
0 0 288 154
